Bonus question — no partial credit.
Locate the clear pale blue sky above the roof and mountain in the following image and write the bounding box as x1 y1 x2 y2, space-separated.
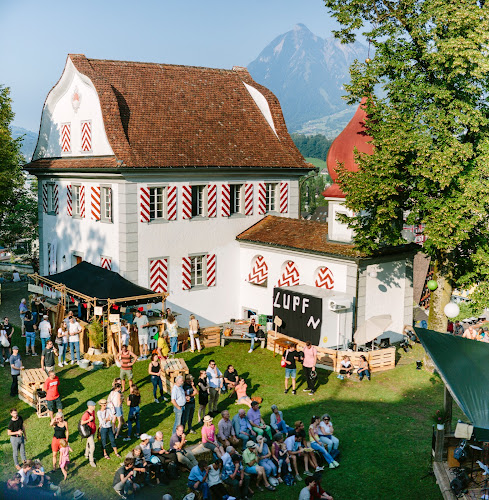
0 0 344 132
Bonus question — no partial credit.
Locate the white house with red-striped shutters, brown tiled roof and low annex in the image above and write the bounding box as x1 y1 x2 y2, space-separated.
26 55 412 344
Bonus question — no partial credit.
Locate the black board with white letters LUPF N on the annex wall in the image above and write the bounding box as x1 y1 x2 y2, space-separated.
273 288 323 345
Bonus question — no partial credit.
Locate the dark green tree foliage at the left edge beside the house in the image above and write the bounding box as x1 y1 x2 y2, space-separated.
0 86 37 254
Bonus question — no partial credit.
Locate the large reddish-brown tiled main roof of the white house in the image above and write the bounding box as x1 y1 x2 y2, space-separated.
28 54 312 169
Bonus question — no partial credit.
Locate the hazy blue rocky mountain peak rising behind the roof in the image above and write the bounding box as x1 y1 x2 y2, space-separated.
248 24 368 137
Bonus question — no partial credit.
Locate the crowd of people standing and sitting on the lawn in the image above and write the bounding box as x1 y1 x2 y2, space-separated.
5 301 340 500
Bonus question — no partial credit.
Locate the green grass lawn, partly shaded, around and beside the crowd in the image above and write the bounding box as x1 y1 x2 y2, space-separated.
0 328 443 500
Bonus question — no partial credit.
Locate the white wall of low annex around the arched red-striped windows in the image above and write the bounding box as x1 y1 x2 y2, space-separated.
238 242 350 314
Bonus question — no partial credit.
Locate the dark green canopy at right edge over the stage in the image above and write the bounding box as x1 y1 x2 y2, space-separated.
415 328 489 441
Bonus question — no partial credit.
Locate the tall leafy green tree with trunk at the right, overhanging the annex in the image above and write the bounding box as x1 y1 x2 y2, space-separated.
325 0 489 331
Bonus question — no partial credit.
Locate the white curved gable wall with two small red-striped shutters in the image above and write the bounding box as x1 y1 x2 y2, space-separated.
32 59 114 160
